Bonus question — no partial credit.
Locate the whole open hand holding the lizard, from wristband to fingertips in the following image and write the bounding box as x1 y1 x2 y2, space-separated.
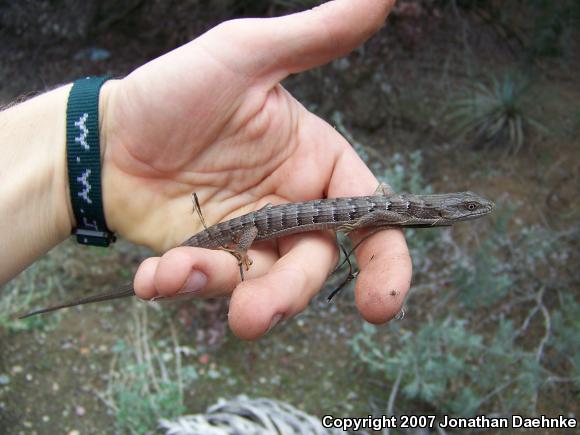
101 0 411 339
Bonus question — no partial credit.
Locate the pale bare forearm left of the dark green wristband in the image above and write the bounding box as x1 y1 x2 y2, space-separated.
0 85 74 284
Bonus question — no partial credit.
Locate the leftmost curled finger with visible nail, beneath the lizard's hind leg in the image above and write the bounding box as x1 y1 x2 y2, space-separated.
135 246 278 299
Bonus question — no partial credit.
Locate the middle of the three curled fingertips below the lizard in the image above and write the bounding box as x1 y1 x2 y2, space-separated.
229 233 338 340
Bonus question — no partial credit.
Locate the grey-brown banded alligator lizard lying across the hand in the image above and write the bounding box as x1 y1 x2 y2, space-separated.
20 184 494 318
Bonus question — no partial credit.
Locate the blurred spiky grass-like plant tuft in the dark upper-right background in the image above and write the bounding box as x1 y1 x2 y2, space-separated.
445 74 545 153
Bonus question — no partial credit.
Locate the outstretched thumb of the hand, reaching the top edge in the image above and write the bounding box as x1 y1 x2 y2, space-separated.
203 0 394 83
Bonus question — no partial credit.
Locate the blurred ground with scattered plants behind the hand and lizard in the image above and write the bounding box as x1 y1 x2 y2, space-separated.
0 0 580 434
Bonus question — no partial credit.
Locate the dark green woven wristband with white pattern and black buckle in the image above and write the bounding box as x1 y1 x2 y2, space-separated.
66 77 115 246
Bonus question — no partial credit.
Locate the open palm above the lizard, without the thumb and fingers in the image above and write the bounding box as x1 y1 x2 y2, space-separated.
106 28 346 250
